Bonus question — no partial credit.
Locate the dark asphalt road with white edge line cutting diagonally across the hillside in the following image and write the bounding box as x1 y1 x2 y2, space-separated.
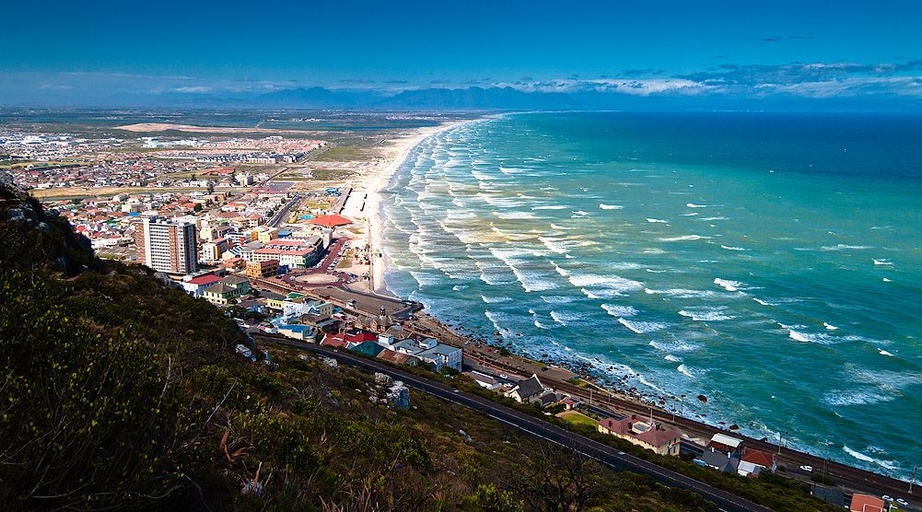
254 335 770 512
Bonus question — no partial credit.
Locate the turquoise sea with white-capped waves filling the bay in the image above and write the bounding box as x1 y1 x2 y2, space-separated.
382 113 922 479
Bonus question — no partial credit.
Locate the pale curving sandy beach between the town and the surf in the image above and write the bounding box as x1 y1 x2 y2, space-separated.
342 121 468 294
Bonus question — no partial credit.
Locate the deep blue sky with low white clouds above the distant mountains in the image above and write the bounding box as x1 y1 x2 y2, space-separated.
0 0 922 106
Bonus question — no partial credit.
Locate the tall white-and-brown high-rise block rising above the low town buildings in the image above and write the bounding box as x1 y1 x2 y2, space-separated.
134 218 198 274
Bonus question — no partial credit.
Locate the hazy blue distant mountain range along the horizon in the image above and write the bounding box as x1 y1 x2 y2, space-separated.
8 86 922 112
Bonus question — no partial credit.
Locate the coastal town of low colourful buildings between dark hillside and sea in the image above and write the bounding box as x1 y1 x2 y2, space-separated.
0 125 908 511
